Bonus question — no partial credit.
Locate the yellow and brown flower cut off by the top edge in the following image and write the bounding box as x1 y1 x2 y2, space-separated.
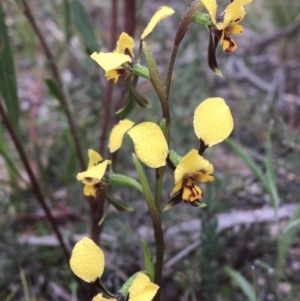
199 0 252 53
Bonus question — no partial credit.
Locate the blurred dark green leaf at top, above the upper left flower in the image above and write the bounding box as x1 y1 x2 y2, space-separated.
71 0 99 54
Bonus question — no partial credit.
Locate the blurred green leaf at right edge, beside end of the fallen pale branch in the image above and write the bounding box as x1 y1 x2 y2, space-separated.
276 205 300 275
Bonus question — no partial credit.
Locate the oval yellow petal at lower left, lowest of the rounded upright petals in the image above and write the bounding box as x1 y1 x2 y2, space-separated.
70 237 104 282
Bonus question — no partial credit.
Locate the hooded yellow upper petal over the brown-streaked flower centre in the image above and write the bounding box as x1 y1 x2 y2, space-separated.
174 149 214 185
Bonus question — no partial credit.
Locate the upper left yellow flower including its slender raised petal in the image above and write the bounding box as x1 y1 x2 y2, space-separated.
91 6 174 83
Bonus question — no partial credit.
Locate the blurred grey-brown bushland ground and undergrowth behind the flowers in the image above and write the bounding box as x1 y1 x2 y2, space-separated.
0 0 300 301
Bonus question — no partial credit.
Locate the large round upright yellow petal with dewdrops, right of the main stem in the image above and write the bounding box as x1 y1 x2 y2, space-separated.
194 97 233 146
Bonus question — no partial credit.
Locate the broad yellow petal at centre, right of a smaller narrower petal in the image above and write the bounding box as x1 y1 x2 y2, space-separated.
128 122 168 168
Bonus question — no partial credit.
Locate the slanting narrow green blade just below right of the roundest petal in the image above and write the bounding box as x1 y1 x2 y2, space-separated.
225 138 271 195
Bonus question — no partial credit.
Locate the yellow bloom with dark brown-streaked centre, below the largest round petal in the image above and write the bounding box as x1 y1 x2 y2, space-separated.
170 149 214 206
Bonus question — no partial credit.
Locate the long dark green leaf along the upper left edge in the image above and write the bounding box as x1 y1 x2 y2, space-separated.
0 1 19 132
